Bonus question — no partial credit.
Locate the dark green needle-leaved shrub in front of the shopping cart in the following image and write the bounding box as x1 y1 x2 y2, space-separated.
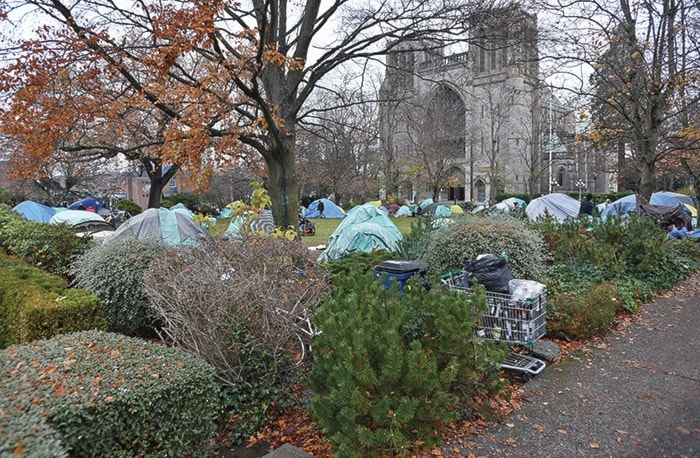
308 273 504 457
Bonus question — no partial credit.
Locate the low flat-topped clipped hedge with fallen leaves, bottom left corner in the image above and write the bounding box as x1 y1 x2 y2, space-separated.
0 331 219 457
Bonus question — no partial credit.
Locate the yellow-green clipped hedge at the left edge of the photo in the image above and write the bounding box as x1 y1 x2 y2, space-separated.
0 258 106 348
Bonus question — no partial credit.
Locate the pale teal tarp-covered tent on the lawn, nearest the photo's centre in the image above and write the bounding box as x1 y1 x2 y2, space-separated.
318 203 403 262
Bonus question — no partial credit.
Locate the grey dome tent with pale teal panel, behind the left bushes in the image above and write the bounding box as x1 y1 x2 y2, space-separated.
105 208 211 245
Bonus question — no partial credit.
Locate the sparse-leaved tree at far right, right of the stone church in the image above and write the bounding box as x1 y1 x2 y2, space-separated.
542 0 700 204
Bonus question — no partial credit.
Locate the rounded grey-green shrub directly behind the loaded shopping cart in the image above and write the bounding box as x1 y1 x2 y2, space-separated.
423 215 549 280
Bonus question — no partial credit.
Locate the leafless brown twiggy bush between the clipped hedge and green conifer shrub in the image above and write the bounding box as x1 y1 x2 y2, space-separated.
146 237 326 386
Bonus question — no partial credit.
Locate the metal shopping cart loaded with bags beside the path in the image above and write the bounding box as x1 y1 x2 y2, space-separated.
443 272 547 380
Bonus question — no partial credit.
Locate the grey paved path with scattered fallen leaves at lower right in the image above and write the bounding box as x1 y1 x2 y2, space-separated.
443 275 700 458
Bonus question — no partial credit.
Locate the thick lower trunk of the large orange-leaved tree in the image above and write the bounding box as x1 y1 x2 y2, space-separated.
265 135 299 229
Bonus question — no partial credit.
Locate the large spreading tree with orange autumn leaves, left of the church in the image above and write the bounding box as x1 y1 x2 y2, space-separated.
0 0 498 227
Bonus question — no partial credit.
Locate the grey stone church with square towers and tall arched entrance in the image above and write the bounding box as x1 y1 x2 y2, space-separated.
380 6 612 203
